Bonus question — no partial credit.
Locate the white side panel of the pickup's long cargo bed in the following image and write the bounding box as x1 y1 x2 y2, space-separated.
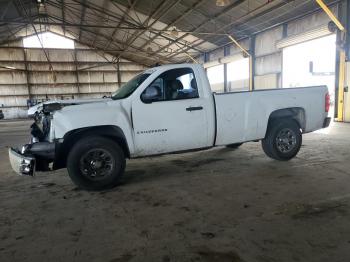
214 86 328 145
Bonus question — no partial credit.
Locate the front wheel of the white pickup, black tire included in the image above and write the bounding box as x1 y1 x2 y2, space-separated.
67 136 125 190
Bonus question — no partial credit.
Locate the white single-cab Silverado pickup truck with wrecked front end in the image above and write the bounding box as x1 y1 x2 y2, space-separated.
9 64 330 190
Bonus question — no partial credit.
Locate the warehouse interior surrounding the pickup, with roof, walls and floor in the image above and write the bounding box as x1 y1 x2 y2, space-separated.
0 0 350 262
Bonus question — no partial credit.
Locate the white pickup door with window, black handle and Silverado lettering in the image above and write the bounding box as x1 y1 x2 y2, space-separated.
132 68 209 156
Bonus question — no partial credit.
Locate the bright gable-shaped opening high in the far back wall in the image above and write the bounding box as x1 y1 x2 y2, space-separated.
23 32 74 49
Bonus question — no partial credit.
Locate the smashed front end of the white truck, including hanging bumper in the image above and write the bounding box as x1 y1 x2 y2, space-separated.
9 103 61 176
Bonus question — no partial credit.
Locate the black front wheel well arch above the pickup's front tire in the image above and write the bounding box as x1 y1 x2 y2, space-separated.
53 125 130 170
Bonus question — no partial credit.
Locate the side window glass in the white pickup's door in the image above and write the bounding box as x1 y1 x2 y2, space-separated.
141 68 199 103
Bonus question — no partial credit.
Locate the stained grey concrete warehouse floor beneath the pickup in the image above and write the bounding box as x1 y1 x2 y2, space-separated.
0 121 350 262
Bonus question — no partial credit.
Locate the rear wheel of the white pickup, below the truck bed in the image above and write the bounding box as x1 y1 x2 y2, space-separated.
261 119 302 161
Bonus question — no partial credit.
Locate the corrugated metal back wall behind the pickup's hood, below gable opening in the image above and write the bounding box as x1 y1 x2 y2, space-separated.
0 41 145 118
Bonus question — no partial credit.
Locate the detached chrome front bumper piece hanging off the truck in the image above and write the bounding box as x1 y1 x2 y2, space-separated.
9 148 36 176
